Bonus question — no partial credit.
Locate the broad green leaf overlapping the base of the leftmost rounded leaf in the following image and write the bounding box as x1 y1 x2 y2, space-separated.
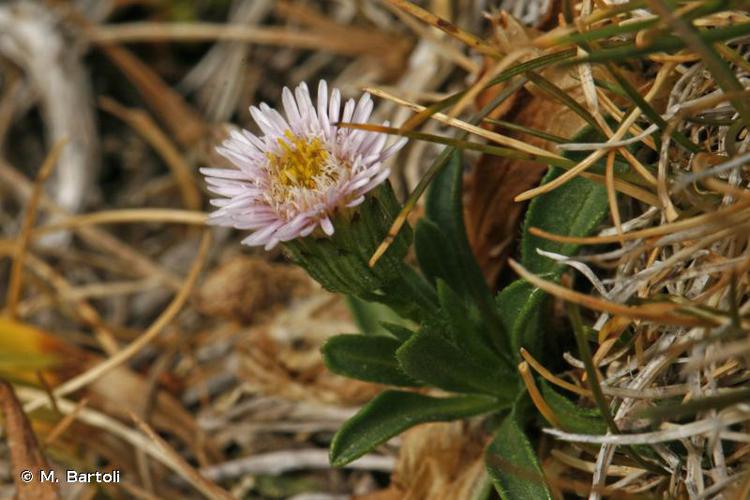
396 324 517 400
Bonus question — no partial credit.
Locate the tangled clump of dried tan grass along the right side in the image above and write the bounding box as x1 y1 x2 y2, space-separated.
536 12 750 498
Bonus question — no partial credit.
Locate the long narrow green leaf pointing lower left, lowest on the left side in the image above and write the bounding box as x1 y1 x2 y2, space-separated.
330 391 497 467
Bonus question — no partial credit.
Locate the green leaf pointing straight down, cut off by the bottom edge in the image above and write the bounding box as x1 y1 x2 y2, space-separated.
485 413 552 500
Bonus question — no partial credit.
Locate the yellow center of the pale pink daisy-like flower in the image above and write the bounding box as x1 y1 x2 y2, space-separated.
267 130 331 189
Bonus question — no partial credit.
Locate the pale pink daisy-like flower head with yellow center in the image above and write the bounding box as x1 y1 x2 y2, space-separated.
201 80 405 250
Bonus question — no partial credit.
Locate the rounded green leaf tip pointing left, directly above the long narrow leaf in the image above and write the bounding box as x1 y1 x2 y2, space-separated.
320 335 420 387
